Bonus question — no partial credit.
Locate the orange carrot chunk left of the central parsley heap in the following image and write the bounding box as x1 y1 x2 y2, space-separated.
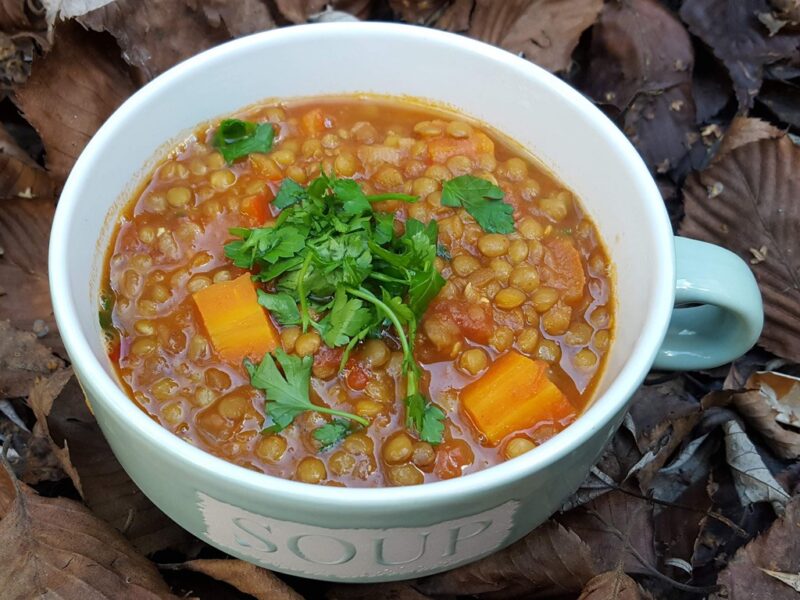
192 273 280 363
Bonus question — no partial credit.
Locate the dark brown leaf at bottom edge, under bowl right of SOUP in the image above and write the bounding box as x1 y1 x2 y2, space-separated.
415 521 597 600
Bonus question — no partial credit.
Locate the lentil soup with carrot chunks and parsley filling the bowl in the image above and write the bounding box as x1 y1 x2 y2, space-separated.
100 96 613 486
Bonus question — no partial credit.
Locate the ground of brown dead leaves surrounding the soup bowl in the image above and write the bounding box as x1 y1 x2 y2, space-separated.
0 0 800 600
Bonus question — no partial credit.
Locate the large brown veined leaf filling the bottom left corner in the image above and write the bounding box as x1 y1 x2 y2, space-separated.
0 461 171 599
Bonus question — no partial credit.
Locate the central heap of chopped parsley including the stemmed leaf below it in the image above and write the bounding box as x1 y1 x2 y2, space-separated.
225 173 445 443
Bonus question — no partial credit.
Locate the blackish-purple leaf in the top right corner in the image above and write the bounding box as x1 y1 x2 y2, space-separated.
680 0 800 113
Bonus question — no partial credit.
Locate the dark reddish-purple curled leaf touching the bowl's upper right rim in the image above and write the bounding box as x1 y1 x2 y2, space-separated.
583 0 699 173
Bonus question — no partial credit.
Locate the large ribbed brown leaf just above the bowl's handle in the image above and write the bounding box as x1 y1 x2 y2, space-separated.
680 137 800 361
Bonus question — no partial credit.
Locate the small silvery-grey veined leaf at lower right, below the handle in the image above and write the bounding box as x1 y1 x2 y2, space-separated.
722 419 790 515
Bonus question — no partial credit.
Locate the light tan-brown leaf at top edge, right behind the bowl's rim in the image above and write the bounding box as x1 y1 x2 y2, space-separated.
437 0 603 72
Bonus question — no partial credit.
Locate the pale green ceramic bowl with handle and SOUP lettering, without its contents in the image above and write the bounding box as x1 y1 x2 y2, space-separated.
50 23 763 582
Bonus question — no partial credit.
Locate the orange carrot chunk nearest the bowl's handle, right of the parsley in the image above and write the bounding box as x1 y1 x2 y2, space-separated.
461 350 575 445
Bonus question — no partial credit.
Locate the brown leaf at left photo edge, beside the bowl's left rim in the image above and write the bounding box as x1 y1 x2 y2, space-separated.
0 198 63 354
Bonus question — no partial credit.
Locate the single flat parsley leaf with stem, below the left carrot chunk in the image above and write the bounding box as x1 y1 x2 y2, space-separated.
244 348 369 433
